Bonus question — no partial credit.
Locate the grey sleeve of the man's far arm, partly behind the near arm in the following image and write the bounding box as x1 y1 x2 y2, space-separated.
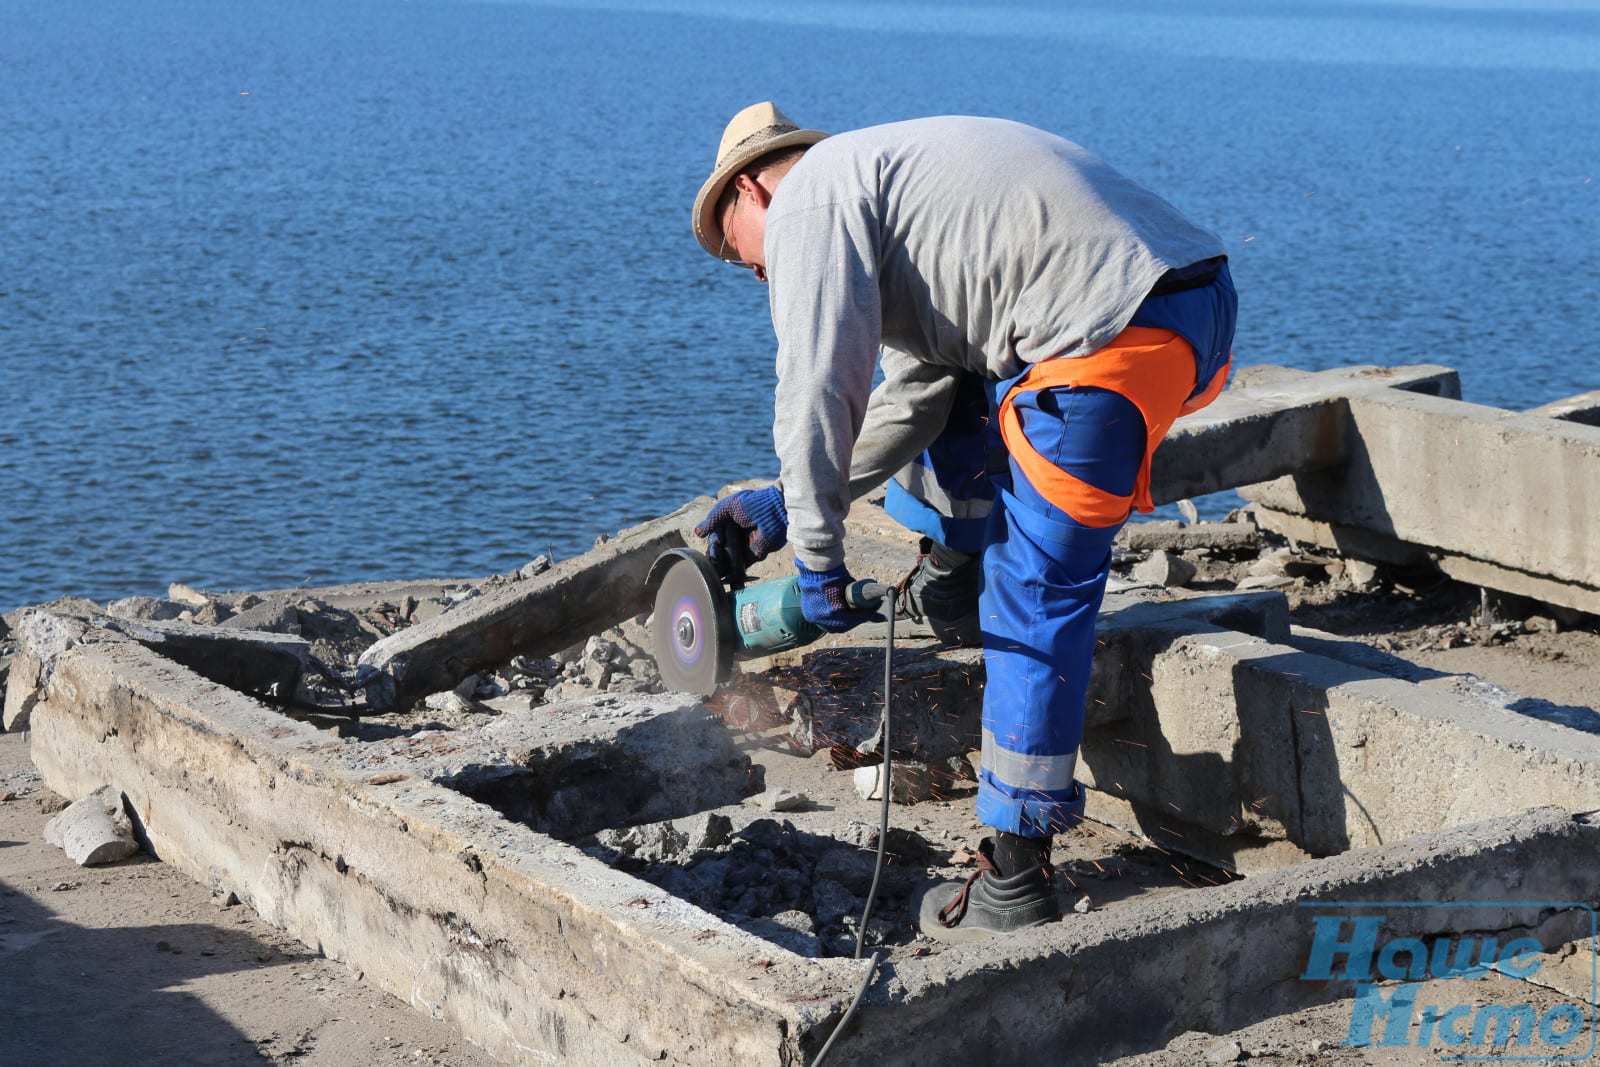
850 346 960 501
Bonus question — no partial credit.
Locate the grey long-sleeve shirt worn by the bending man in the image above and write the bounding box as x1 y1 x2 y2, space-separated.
765 117 1222 569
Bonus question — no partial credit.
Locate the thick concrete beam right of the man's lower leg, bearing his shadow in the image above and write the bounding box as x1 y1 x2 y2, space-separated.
1078 625 1600 872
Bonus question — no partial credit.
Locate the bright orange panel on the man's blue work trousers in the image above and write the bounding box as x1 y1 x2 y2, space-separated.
1000 326 1232 526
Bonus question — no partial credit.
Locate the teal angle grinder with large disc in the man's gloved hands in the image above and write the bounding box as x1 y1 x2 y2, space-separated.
648 549 893 696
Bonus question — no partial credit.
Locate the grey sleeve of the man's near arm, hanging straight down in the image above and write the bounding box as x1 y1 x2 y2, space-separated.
765 198 882 569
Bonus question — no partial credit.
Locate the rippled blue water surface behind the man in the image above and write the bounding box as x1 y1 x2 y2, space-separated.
0 0 1600 609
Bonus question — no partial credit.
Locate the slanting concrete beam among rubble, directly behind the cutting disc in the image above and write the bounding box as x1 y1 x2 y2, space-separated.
360 498 712 709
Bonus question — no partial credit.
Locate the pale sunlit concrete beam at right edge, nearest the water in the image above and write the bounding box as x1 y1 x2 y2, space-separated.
1240 390 1600 600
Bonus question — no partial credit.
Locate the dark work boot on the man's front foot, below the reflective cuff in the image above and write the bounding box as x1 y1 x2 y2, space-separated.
912 837 1061 944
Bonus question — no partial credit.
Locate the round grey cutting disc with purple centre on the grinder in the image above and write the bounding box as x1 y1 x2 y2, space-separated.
651 549 733 696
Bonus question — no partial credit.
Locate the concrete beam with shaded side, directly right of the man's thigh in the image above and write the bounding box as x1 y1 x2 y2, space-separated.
1150 365 1461 504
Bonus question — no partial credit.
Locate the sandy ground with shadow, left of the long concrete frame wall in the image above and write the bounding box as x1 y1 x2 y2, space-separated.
0 733 494 1067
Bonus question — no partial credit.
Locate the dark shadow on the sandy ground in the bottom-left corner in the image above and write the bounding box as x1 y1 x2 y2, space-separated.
0 881 274 1067
